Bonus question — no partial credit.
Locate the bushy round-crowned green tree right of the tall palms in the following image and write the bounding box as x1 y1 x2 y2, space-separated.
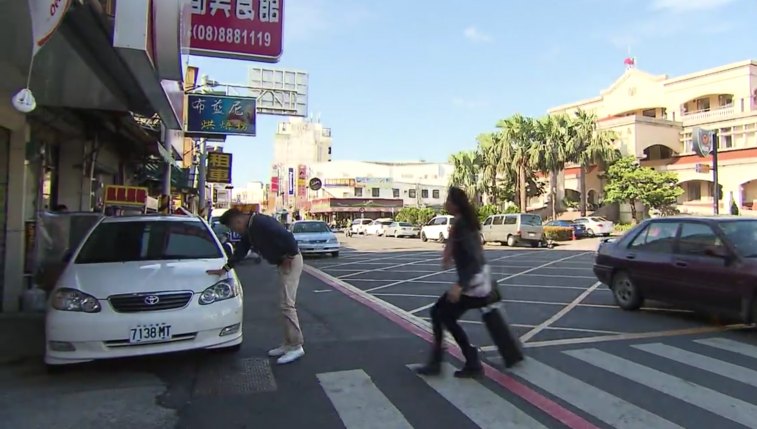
605 156 683 222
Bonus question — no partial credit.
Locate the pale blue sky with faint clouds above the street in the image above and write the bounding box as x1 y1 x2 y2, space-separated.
190 0 757 185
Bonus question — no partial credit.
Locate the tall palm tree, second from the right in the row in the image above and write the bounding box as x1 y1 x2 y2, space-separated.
530 115 571 219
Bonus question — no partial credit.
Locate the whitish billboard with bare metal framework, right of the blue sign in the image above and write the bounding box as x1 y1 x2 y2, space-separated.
248 67 310 116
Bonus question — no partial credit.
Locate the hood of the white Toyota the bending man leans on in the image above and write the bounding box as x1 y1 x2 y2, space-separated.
58 259 226 299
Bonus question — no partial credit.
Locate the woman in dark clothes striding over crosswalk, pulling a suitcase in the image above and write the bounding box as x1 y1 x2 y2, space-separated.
418 187 492 378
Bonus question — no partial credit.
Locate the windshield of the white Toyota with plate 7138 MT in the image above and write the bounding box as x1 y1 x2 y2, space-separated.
75 220 223 264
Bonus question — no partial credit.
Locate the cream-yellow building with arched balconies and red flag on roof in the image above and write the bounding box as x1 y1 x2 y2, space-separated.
549 60 757 214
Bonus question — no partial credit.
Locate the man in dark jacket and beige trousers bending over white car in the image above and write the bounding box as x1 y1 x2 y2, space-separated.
207 208 305 364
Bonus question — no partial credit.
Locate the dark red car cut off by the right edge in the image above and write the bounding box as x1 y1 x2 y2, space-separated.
594 216 757 323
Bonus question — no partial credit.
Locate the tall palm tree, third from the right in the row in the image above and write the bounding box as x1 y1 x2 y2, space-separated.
497 114 534 212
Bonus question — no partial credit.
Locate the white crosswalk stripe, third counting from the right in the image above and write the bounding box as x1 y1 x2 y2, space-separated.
563 349 757 427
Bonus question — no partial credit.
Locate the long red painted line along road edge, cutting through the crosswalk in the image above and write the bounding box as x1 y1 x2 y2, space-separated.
305 265 600 429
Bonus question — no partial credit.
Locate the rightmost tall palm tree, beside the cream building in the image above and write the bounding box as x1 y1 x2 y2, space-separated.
568 109 620 216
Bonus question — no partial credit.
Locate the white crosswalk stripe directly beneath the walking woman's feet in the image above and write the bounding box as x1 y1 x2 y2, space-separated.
408 364 546 429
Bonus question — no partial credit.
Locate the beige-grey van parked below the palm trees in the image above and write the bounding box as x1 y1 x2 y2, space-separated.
481 213 544 247
